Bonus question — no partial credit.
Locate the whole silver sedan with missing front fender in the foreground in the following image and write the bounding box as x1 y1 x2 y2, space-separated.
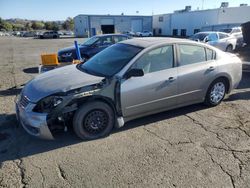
16 38 242 139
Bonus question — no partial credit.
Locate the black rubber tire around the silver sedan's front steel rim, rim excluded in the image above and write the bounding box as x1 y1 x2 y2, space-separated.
73 101 115 140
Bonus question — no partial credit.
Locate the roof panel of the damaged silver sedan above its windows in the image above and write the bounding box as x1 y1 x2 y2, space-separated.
120 37 200 48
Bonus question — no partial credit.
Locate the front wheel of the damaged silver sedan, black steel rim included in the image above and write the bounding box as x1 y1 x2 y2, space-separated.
73 102 115 140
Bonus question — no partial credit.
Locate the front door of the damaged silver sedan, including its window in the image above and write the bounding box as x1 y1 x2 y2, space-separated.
121 45 177 117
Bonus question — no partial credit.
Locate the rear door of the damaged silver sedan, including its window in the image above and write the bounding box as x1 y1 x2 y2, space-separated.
177 44 217 105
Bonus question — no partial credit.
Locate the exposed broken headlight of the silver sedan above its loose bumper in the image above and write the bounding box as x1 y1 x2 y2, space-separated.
34 96 63 113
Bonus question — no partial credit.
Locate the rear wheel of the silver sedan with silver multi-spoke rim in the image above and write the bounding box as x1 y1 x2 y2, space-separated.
204 79 228 107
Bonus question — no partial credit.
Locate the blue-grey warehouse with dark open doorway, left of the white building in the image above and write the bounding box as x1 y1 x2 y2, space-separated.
74 14 152 37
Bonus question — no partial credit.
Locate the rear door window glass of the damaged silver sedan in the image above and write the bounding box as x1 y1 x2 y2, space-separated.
179 44 206 66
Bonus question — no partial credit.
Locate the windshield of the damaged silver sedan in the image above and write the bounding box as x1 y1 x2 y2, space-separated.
80 43 142 77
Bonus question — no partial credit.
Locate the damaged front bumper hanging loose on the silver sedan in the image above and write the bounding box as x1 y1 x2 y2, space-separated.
15 99 54 140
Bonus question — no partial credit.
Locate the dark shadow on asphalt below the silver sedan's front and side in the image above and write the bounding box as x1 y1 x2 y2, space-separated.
0 105 205 163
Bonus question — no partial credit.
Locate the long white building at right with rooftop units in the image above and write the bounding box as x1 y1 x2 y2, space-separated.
153 3 250 36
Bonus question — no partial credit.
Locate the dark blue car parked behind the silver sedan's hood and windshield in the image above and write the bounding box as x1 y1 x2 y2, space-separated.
58 34 131 62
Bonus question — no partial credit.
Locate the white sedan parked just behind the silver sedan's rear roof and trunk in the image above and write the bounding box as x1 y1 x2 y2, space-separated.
190 31 237 52
